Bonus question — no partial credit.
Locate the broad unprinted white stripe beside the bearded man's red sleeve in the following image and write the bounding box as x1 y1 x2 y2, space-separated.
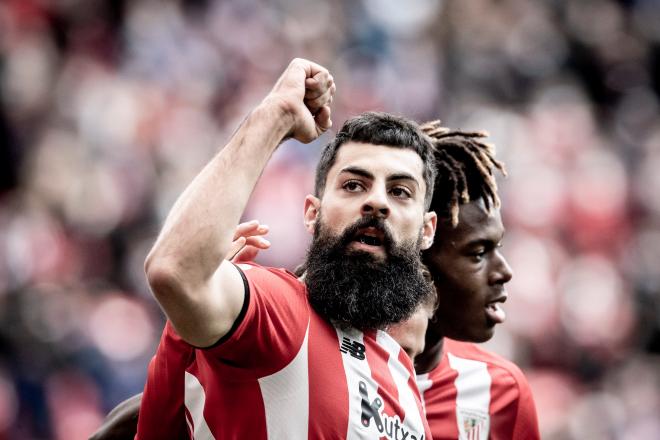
259 322 309 440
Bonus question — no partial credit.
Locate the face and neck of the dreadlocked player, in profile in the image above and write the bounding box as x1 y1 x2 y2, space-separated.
425 200 512 342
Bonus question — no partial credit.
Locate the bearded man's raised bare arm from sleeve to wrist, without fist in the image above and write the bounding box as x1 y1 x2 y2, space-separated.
145 102 290 346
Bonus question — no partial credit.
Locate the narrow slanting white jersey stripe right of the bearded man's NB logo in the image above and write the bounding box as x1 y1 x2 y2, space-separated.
376 330 424 434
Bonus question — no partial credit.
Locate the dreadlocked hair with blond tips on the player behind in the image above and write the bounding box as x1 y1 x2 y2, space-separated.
421 120 506 226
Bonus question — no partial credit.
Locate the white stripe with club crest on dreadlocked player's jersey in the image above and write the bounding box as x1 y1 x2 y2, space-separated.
447 353 491 440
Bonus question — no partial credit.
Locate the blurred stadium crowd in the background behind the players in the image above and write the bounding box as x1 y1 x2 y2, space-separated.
0 0 660 440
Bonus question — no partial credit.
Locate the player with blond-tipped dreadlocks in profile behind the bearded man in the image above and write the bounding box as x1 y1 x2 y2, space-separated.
404 121 540 440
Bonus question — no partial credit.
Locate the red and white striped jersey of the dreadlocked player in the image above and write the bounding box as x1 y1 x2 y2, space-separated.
417 338 540 440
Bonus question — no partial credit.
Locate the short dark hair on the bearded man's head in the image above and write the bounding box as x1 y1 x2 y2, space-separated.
314 112 436 209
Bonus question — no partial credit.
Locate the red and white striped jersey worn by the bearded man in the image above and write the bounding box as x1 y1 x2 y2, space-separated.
138 264 430 440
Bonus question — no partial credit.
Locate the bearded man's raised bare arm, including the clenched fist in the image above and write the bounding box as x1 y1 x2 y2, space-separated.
145 59 335 347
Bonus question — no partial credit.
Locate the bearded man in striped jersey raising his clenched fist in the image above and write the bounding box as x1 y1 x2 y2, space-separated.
138 59 436 440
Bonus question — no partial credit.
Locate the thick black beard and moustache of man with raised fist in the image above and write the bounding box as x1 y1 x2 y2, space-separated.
305 217 432 330
